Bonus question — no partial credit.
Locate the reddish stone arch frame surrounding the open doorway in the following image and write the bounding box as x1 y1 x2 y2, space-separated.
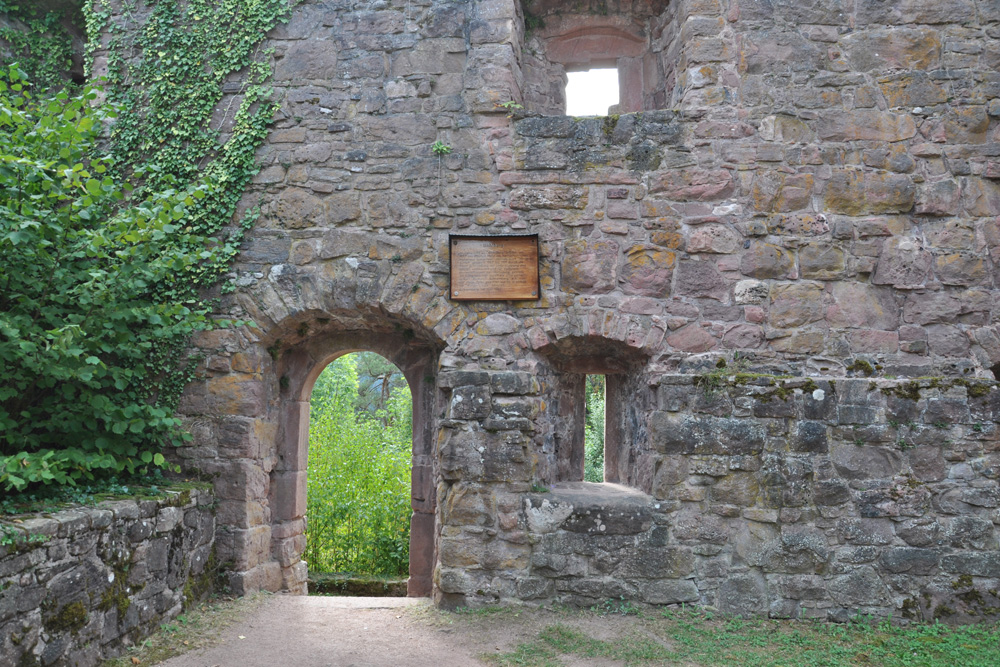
269 331 437 597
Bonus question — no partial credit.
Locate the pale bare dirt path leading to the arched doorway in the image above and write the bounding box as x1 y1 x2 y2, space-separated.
155 595 631 667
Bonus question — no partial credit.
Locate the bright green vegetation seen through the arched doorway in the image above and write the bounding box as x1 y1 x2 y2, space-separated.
305 352 413 576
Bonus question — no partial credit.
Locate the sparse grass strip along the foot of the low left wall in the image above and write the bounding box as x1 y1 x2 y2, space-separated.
101 593 270 667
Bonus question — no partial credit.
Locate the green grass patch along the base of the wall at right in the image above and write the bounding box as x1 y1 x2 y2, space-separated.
482 609 1000 667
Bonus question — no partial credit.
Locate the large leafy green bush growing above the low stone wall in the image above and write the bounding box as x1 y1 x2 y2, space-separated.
0 66 223 490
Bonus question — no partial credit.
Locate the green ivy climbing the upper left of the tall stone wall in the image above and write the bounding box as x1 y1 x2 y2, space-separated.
88 0 297 292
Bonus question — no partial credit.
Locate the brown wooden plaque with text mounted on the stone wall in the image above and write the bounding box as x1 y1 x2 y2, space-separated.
449 234 541 301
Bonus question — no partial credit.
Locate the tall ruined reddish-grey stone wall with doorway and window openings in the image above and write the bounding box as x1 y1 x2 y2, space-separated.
88 0 1000 620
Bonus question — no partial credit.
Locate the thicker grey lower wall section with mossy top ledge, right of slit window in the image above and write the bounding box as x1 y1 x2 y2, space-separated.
508 374 1000 622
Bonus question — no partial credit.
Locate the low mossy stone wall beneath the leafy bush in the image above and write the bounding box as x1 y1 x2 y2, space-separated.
0 489 215 667
